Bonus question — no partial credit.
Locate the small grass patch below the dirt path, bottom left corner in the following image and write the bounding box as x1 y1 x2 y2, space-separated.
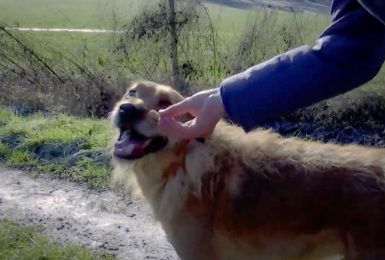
0 220 115 260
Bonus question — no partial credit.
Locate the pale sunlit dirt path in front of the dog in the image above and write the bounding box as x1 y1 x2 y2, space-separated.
0 167 178 260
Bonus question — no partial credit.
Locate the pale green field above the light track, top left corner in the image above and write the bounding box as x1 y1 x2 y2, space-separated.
0 0 155 28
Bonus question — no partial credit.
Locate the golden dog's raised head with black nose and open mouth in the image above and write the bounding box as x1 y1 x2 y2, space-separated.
111 81 183 160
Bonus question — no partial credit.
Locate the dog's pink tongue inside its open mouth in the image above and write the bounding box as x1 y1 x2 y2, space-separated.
114 131 147 159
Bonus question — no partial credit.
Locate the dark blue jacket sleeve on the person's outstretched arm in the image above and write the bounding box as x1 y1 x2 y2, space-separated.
220 0 385 131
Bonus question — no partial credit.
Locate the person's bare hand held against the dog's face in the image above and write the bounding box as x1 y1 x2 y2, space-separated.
159 88 225 139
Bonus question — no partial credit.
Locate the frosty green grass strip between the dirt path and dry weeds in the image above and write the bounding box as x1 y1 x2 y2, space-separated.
0 107 113 188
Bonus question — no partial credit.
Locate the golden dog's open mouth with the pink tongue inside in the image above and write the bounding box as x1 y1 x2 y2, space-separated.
114 129 168 160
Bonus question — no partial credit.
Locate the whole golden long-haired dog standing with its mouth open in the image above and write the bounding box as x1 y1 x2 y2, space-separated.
111 81 385 260
